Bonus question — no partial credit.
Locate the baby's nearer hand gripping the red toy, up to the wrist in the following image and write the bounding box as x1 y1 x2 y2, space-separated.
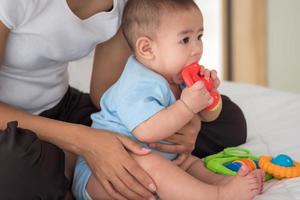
180 81 213 114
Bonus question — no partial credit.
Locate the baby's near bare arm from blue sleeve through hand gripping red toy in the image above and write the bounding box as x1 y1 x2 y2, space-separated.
132 81 210 143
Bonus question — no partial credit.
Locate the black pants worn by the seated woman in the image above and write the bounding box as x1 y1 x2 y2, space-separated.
0 88 247 200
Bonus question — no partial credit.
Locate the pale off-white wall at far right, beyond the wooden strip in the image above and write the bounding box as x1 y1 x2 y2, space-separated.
267 0 300 93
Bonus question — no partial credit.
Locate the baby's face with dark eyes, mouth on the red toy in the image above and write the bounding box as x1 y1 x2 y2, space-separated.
154 8 203 84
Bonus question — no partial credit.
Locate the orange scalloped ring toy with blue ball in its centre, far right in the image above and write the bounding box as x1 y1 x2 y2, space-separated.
259 154 300 179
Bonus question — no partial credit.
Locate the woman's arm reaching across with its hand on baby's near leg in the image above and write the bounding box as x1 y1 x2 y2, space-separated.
0 21 154 199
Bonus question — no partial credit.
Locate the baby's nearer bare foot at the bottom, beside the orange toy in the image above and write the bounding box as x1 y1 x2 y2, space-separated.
219 168 263 200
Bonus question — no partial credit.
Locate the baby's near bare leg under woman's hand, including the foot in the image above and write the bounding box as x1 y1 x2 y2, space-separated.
87 154 259 200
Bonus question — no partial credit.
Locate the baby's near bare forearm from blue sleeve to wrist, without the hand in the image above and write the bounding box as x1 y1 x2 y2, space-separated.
133 100 194 143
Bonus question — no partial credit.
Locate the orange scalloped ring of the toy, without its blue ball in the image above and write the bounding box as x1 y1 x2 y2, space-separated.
258 156 300 179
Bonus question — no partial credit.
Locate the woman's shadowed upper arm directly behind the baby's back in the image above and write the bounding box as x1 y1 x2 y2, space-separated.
90 29 131 107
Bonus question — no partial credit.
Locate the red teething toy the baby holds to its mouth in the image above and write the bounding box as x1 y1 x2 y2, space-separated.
181 63 221 111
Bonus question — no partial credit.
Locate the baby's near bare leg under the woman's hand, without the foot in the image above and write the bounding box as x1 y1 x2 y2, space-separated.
87 153 218 200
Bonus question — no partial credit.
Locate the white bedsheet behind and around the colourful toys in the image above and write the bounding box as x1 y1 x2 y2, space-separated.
220 82 300 200
